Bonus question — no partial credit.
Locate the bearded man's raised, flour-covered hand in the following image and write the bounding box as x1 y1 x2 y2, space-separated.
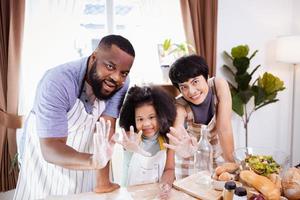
92 118 114 169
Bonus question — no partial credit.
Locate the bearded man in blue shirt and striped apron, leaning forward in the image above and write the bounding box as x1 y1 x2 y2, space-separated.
14 35 135 199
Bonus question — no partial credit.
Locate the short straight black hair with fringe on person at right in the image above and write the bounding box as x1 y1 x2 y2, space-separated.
169 55 208 89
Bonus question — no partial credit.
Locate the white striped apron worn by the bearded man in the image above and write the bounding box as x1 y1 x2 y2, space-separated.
14 99 105 200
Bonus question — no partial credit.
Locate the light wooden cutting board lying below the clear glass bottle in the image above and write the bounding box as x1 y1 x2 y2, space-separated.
173 172 222 200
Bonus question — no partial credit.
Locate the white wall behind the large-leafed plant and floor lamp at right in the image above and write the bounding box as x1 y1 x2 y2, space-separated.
217 0 300 164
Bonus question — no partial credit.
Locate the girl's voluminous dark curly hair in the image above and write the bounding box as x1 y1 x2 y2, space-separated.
119 86 176 139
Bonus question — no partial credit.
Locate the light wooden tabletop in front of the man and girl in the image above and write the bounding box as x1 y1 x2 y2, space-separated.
46 183 196 200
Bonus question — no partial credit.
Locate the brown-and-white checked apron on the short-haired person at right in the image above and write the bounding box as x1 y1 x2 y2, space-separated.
175 78 223 179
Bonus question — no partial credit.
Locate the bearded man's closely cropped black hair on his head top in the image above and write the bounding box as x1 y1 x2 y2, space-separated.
98 35 135 57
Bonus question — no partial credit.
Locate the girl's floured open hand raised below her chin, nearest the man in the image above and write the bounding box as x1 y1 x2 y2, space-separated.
114 126 151 156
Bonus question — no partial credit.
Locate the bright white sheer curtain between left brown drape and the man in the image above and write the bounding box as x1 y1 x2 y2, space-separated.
20 0 82 114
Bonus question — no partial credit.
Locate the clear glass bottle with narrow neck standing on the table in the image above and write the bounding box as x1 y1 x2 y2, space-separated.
194 125 213 174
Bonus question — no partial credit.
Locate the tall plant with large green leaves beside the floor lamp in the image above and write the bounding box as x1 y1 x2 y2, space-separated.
223 45 285 147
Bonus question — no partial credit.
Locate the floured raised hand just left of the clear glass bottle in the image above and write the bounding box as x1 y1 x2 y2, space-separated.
163 127 197 158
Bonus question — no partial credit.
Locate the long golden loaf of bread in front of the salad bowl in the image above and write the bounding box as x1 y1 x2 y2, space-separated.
240 170 280 200
